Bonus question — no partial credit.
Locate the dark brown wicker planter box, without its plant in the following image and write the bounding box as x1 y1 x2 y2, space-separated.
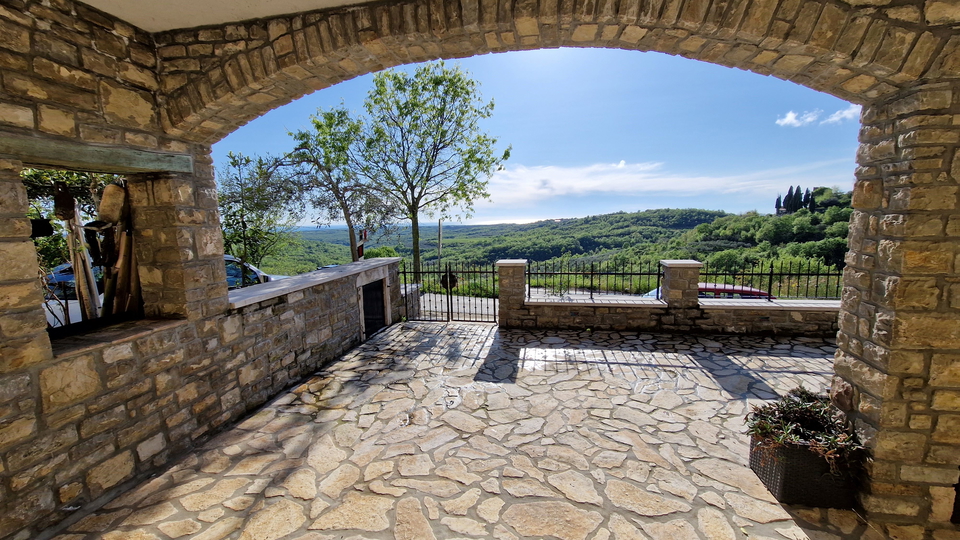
750 437 857 508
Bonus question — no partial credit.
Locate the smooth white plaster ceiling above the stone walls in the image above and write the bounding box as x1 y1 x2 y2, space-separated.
83 0 363 32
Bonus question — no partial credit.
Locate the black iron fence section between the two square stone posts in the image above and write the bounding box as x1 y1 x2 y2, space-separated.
527 261 661 300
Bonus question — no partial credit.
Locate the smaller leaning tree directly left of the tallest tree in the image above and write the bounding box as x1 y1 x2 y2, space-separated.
285 106 394 261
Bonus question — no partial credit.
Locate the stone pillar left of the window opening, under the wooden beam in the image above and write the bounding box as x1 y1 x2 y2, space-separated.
0 156 53 374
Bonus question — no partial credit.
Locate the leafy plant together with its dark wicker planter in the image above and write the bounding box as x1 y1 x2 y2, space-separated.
746 386 868 508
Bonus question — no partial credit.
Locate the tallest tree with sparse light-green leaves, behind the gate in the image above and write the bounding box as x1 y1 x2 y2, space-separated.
361 62 510 278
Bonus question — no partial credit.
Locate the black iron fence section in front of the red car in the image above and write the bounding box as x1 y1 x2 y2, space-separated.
700 261 843 301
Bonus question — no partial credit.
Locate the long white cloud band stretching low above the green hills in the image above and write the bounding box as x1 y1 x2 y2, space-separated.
484 160 846 208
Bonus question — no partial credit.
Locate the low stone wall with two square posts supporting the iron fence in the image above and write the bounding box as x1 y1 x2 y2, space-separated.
497 259 840 337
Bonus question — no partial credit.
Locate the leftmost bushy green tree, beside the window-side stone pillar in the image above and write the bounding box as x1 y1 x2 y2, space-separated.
217 152 302 266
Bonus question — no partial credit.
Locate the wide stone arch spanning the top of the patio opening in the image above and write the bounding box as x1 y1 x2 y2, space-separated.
156 0 960 143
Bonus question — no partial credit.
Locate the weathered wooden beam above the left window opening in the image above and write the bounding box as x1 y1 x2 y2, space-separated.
0 131 193 174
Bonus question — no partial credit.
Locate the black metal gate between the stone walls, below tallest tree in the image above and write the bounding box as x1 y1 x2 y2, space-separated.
400 261 499 322
